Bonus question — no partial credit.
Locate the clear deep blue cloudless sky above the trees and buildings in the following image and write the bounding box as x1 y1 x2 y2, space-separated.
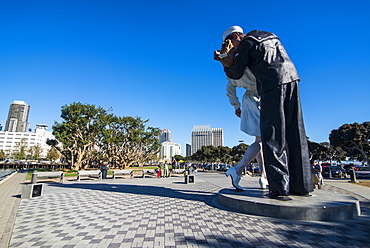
0 0 370 155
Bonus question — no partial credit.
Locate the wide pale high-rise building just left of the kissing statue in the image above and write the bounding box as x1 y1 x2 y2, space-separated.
191 125 224 154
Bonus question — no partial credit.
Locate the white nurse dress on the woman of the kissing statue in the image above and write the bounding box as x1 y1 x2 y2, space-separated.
226 67 261 136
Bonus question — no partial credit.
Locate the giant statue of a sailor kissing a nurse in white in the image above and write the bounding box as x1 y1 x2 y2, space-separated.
214 26 313 200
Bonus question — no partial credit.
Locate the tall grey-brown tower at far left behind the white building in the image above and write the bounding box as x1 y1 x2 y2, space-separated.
4 101 30 132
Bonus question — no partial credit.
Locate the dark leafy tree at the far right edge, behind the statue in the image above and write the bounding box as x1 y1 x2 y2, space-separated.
329 122 370 164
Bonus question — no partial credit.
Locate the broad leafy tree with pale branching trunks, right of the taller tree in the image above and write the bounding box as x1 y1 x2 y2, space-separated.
98 116 160 168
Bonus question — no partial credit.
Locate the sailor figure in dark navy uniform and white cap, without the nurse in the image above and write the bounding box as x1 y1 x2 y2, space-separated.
214 26 313 200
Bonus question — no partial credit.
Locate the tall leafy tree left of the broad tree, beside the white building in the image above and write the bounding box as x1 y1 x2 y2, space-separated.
47 102 110 170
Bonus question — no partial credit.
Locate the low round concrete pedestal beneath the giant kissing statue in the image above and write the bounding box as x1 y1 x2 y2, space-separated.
218 189 361 221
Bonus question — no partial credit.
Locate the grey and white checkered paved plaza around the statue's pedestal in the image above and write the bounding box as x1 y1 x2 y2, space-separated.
0 172 370 248
